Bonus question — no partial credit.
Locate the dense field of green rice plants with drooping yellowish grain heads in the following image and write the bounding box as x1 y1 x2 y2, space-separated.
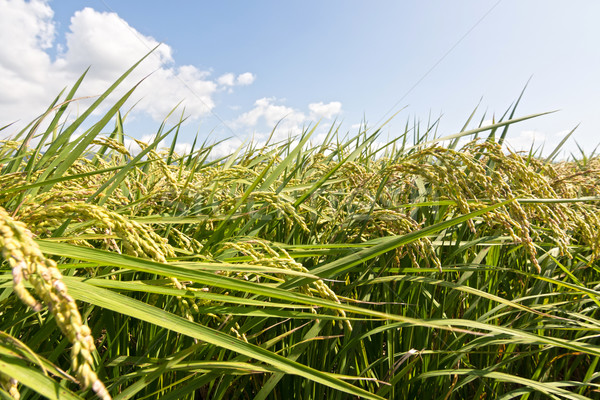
0 57 600 400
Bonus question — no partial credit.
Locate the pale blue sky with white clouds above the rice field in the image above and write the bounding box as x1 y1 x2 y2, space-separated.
0 0 600 157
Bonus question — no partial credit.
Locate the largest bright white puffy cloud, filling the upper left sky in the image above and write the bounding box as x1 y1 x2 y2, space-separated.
0 0 254 126
